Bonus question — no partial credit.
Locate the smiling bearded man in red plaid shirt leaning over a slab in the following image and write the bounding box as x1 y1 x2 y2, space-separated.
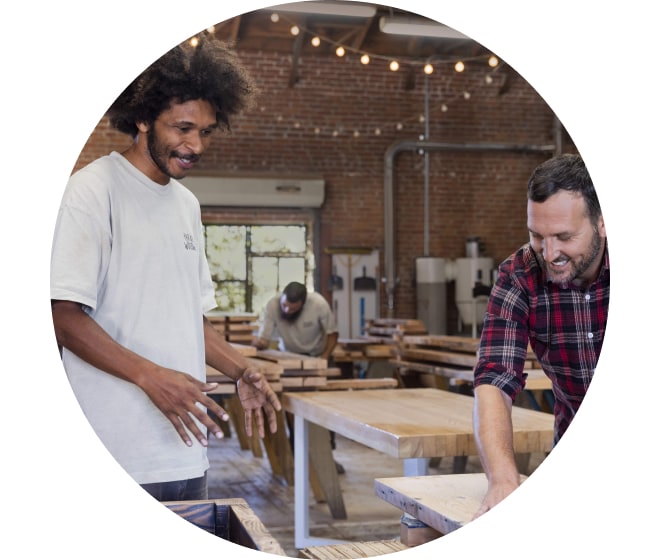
474 154 610 517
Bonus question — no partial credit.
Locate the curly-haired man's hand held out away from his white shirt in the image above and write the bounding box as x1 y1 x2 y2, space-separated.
236 368 282 438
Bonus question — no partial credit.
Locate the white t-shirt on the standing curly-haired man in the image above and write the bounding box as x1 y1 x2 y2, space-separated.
51 152 216 484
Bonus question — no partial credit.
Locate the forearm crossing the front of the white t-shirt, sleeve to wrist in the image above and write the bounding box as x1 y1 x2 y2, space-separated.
51 301 159 386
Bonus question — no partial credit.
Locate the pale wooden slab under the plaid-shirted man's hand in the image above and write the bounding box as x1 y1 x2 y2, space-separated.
374 473 525 535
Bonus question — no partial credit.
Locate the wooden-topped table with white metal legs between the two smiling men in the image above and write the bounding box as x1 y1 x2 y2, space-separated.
282 388 554 548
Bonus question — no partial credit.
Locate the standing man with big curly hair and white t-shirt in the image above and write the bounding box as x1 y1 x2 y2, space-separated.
51 35 281 501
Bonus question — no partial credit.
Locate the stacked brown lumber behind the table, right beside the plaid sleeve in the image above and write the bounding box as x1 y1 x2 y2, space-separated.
391 335 539 388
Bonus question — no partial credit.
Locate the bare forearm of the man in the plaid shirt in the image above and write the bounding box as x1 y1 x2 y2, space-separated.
473 385 520 485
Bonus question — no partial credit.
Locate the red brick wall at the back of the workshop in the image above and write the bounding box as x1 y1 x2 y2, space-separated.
76 50 575 329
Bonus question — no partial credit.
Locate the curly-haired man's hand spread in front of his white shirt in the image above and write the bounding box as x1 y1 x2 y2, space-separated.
139 368 229 447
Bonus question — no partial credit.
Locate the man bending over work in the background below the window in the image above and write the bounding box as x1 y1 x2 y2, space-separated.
253 282 339 361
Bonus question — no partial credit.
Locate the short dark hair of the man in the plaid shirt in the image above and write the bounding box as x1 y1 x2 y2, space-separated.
527 154 602 224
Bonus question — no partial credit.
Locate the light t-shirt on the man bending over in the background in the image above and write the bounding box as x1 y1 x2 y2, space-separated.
259 292 337 356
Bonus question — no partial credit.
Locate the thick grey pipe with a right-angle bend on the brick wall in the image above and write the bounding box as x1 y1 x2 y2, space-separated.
382 140 556 317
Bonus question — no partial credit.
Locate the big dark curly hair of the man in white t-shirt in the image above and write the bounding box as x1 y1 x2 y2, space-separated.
106 32 257 137
